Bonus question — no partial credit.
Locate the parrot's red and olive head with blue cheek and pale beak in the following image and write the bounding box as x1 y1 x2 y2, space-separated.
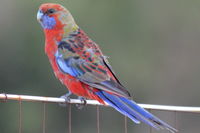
37 3 77 31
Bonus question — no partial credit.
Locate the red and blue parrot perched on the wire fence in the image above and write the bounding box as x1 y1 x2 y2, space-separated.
37 3 178 133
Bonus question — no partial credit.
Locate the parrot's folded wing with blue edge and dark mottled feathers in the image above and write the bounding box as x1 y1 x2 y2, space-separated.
55 39 130 98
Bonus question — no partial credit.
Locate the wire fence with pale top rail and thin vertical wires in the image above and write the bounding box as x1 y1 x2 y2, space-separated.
0 94 200 133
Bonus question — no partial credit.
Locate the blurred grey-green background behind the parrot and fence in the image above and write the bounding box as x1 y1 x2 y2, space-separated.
0 0 200 133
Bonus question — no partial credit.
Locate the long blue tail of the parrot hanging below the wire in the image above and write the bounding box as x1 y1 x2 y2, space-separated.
96 91 177 133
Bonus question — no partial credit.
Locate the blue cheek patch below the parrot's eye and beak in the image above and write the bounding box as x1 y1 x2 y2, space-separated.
42 15 56 29
